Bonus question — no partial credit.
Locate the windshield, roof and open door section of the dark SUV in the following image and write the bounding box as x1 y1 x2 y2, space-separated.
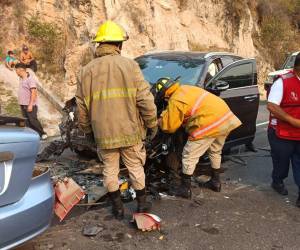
136 51 259 148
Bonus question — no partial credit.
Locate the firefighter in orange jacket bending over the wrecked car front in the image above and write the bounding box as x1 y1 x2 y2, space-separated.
156 78 241 198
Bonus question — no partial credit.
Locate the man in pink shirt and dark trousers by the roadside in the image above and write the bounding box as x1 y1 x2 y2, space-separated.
15 63 47 140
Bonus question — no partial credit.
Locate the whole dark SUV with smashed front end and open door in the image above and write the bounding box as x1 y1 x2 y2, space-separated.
38 51 259 165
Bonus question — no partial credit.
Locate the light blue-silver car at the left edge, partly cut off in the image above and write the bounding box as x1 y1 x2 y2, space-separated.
0 116 54 249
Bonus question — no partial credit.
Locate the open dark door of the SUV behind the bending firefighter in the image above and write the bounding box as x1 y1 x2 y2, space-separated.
205 59 259 146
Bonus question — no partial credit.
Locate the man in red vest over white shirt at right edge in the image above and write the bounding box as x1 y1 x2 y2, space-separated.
267 54 300 207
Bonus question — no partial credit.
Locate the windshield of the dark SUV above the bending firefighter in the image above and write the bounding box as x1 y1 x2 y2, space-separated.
136 56 204 85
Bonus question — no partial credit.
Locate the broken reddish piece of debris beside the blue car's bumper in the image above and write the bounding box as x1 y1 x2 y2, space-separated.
54 178 85 221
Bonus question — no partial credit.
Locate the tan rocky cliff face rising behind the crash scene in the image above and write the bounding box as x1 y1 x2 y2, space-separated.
0 0 300 99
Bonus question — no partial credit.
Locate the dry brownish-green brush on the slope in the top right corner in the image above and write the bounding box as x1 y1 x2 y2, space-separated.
224 0 300 68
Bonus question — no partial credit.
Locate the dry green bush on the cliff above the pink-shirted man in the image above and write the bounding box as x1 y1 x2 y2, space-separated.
27 16 63 63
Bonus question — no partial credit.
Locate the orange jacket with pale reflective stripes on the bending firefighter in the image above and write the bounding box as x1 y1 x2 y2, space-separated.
161 85 241 140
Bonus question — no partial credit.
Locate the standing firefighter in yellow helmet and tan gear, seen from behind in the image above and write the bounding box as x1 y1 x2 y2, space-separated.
76 21 157 219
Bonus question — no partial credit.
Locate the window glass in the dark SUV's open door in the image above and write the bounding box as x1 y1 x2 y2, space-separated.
213 63 253 89
